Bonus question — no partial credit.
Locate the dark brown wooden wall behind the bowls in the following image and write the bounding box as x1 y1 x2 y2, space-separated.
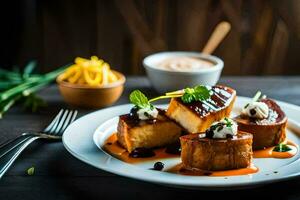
0 0 300 75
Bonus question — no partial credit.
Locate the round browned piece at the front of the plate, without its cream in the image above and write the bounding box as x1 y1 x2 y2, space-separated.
180 132 252 171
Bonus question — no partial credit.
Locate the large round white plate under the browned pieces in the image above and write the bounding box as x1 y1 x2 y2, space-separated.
63 97 300 189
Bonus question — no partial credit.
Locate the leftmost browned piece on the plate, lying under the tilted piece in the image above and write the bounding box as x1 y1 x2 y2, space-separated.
117 110 182 152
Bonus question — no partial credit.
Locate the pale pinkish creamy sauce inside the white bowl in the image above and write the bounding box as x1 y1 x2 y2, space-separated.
157 56 214 71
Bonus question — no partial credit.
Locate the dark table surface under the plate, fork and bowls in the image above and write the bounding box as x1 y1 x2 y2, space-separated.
0 76 300 200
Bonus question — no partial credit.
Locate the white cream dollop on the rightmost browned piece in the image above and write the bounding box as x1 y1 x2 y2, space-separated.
242 101 269 119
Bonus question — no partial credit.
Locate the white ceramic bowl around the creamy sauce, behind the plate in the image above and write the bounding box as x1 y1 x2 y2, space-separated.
143 51 224 93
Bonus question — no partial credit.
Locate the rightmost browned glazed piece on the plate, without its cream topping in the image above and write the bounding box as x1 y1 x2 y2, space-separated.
234 99 287 150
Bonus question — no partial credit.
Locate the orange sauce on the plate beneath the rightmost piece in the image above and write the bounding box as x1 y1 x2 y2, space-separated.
253 140 298 159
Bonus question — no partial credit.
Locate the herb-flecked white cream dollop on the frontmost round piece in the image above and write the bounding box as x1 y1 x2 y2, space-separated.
206 118 238 139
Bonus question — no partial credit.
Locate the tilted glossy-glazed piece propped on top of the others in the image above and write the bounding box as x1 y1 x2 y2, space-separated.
166 85 236 133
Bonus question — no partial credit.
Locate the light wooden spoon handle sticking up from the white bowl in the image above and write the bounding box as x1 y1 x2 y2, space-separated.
202 22 231 54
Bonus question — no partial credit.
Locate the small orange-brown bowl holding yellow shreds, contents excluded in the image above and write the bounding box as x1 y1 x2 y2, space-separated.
56 70 126 108
